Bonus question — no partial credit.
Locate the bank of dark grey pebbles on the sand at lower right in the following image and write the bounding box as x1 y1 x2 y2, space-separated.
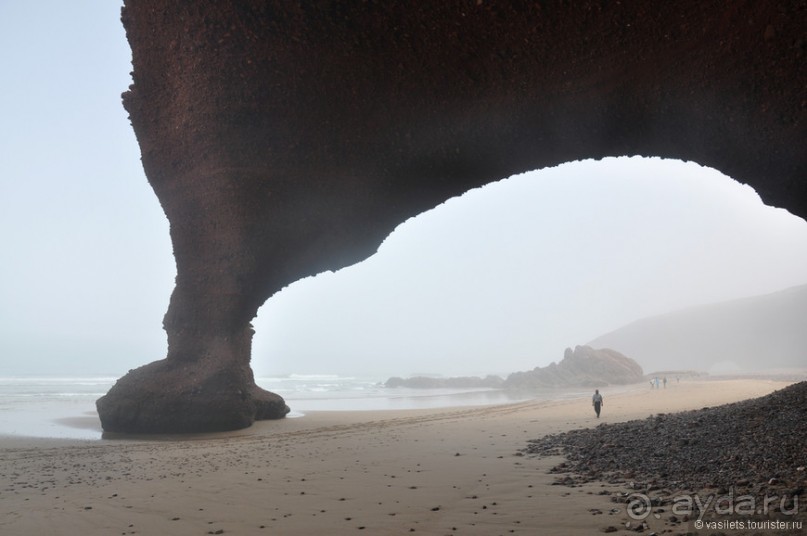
519 381 807 534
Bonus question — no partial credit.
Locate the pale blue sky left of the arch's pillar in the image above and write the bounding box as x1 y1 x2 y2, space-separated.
0 0 174 375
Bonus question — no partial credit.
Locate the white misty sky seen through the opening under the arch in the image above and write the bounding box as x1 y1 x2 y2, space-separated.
254 158 807 376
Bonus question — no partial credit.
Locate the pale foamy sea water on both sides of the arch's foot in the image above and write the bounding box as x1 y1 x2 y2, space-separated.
0 374 544 439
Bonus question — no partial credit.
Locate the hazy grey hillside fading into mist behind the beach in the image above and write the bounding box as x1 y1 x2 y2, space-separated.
587 285 807 373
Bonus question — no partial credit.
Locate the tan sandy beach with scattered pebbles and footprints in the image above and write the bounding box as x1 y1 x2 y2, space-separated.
0 379 787 536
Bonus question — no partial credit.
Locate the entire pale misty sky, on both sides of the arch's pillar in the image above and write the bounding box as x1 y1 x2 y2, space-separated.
0 0 807 377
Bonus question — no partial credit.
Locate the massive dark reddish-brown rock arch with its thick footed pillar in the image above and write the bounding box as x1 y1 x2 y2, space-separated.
97 0 807 432
